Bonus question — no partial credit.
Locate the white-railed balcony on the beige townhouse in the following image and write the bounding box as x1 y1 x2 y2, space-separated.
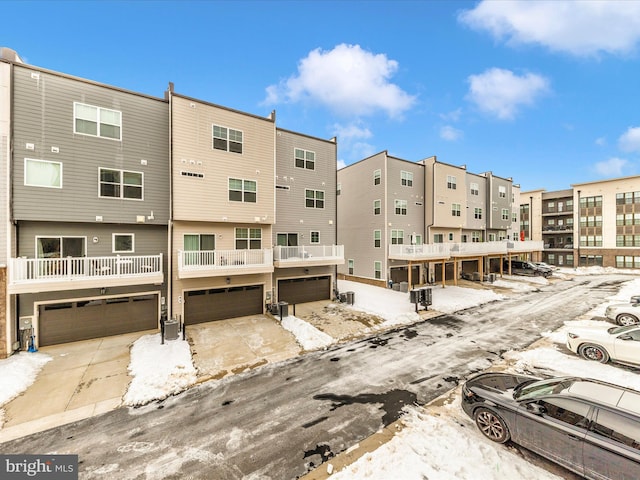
178 248 273 278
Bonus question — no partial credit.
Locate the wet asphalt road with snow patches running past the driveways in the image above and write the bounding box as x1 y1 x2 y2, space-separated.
0 276 629 480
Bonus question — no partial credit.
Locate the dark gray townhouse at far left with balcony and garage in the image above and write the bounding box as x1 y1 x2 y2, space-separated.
0 50 170 354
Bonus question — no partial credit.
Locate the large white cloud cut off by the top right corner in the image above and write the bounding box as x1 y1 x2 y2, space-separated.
458 0 640 56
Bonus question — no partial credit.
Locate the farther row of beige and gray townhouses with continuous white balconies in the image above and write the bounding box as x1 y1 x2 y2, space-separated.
338 156 542 286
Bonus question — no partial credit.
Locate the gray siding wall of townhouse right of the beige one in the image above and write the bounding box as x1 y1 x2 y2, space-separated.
272 129 337 246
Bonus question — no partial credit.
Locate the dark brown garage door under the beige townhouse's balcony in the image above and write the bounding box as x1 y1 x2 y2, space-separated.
184 285 263 325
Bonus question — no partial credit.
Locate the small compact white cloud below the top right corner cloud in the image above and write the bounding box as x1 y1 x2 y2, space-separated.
467 68 549 120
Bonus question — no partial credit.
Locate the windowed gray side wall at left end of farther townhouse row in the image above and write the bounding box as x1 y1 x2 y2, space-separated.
338 152 389 278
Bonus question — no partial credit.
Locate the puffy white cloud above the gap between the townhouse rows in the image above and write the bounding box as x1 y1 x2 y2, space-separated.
265 44 415 117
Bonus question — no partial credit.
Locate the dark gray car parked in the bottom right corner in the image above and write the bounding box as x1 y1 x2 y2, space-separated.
462 373 640 480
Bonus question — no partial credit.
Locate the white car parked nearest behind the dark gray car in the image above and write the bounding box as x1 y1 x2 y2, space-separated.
567 325 640 367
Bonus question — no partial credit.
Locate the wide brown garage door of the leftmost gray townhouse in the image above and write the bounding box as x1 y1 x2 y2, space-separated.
37 295 158 346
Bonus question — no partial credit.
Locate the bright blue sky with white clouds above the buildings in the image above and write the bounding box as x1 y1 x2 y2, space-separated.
0 0 640 190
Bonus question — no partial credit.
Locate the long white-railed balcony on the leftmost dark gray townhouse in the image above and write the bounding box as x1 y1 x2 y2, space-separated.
8 254 164 294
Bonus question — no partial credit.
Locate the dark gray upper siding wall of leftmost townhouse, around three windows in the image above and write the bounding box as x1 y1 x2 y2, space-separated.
13 65 169 225
